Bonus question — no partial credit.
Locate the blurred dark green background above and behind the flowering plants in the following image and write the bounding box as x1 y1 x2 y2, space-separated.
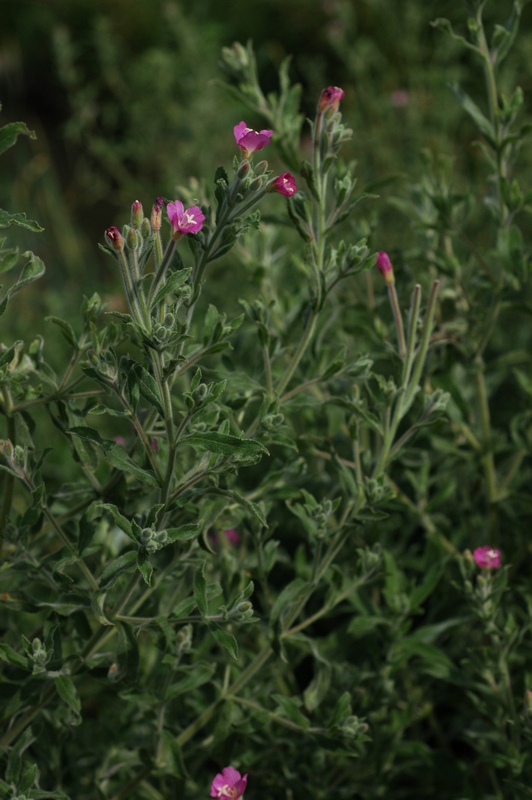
0 0 532 330
